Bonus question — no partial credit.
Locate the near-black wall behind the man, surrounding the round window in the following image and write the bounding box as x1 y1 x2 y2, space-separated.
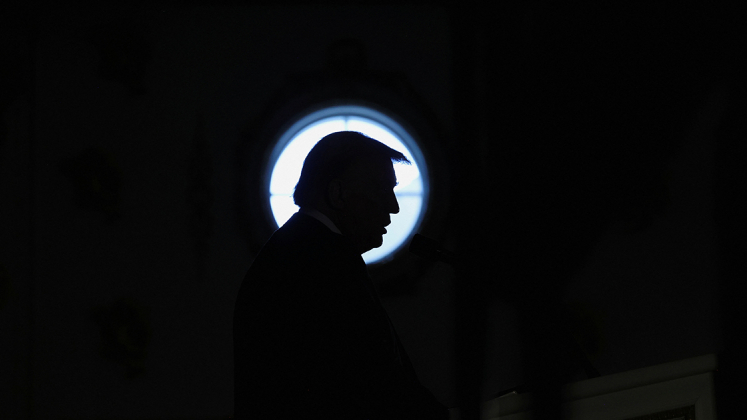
0 4 730 418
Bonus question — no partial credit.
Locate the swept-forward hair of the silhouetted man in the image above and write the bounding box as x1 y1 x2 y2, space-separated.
293 131 410 207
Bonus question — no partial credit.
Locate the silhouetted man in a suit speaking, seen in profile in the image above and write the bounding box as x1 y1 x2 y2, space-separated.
233 131 448 419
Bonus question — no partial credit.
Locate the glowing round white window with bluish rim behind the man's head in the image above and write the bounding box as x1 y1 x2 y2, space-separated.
265 105 428 264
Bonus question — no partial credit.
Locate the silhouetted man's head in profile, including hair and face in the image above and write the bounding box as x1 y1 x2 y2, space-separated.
293 131 410 253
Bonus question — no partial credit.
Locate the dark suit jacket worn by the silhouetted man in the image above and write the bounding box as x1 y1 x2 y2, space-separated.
233 213 448 419
